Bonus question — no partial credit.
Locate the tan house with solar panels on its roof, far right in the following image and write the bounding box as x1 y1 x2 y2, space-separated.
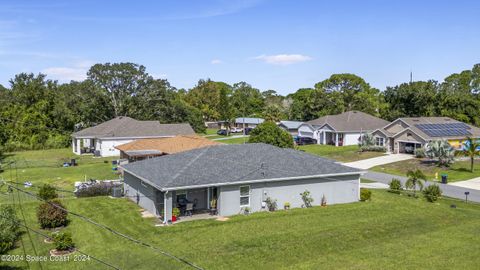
372 117 480 154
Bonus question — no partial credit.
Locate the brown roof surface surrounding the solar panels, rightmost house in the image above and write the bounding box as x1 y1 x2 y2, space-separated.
386 117 480 141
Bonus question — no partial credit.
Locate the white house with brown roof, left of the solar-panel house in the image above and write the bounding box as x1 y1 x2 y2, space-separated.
298 111 388 146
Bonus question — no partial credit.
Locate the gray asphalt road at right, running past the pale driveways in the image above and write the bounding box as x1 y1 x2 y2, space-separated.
362 171 480 203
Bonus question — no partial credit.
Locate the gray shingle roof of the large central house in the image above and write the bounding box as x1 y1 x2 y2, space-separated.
123 143 360 189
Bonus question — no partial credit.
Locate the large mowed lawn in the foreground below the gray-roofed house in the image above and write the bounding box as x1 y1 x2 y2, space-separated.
4 190 480 269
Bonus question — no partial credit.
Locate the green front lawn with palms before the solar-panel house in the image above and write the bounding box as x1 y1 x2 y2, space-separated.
371 159 480 182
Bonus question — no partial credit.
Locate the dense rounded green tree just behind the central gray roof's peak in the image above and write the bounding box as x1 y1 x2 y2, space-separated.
248 121 293 148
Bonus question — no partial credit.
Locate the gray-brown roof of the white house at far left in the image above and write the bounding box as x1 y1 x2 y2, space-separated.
72 116 195 138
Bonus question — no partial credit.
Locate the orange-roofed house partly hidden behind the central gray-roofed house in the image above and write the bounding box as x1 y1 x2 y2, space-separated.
115 135 220 162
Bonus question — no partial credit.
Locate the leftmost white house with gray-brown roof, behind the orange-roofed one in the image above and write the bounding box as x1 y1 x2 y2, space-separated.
72 116 195 157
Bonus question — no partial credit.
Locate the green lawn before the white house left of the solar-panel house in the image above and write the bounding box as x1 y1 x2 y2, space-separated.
298 144 384 162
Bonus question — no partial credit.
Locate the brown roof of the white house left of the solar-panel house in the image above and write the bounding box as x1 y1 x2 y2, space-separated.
307 111 389 132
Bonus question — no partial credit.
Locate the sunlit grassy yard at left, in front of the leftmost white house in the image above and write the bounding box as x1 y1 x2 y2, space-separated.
0 148 118 190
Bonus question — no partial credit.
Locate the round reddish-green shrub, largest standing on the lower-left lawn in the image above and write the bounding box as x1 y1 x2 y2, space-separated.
37 200 67 229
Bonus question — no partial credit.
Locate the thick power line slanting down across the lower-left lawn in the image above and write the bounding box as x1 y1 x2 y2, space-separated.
6 183 203 270
